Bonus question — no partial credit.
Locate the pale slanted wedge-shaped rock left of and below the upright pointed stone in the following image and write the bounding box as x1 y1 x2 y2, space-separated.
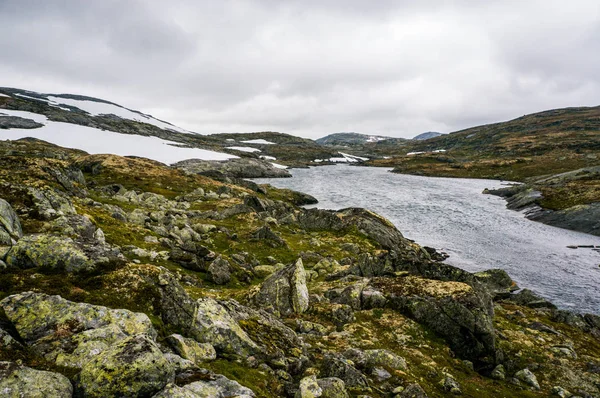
189 298 258 356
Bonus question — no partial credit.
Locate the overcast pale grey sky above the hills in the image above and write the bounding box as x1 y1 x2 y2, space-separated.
0 0 600 138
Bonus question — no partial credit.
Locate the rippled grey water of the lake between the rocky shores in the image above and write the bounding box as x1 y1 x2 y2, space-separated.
256 165 600 314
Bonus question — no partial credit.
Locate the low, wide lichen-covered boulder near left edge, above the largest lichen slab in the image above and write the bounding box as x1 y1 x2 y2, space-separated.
6 234 95 272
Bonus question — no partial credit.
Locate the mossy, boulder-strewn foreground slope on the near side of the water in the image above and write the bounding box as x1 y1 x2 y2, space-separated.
0 139 600 398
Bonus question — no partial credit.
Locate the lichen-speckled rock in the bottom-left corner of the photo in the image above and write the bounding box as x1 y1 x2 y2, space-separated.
0 362 73 398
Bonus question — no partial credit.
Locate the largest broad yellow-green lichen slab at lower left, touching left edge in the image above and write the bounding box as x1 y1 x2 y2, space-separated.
0 292 156 368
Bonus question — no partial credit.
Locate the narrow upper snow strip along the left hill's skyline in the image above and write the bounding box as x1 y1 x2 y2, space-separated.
48 95 194 134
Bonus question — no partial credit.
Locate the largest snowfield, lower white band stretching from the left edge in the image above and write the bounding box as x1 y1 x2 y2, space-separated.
0 109 237 164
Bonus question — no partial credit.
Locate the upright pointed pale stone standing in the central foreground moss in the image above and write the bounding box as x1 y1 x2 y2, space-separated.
251 259 309 316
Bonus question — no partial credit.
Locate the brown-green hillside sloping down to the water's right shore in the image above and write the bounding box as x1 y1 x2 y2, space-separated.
369 107 600 234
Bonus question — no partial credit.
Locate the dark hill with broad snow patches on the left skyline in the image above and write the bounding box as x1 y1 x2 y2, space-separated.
0 87 337 166
